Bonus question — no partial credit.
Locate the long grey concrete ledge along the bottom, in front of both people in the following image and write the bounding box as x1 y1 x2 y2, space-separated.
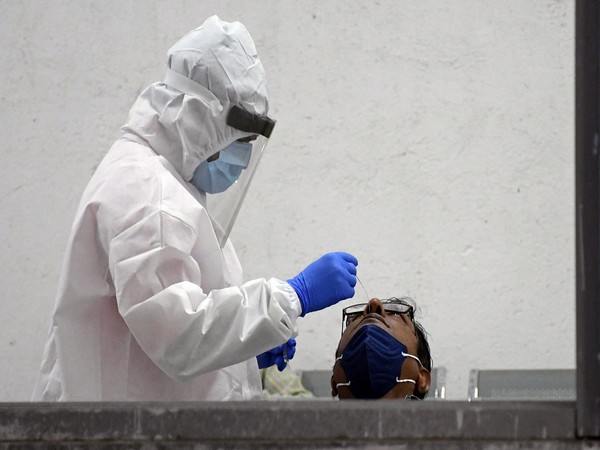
0 400 600 449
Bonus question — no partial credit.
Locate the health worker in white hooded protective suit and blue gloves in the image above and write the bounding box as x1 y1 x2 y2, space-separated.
32 16 358 401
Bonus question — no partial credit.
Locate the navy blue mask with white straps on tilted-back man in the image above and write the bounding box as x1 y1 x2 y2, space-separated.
338 325 421 398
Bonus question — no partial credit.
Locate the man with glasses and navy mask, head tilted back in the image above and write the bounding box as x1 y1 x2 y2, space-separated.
331 297 431 400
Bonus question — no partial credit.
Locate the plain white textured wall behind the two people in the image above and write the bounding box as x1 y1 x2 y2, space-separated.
0 0 575 401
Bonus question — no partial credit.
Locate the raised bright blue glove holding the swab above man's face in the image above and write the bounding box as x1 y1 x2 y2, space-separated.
288 252 358 316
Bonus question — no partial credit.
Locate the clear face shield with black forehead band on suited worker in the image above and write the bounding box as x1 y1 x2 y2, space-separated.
206 105 275 247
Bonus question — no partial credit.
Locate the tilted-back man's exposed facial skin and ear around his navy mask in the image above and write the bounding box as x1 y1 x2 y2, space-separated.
331 298 431 399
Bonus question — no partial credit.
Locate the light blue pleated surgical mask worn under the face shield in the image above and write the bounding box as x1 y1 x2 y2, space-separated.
191 141 252 194
